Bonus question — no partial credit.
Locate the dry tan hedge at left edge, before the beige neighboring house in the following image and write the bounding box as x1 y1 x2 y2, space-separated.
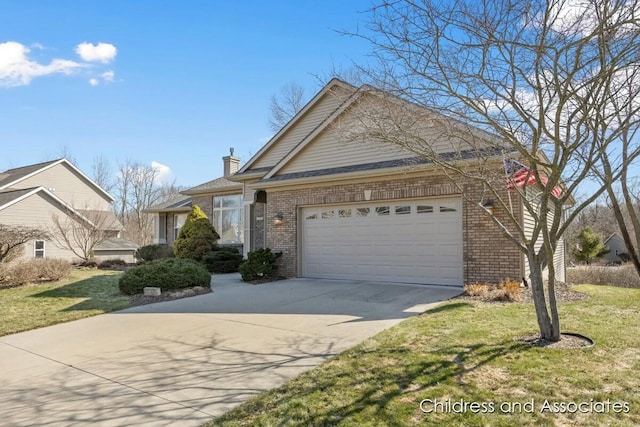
0 258 71 287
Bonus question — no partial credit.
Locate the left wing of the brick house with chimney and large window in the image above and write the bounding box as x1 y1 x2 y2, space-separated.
145 149 245 250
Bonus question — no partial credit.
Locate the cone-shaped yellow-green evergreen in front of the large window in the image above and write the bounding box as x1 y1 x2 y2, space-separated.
173 205 220 261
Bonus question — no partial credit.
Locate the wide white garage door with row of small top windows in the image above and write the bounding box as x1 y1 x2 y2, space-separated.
301 198 463 286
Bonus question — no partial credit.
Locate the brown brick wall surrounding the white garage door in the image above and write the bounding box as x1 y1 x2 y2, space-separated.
265 176 521 282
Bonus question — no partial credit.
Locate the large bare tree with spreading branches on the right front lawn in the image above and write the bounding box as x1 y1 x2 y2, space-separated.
345 0 640 341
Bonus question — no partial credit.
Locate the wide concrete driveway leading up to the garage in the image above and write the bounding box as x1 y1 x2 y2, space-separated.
0 275 461 426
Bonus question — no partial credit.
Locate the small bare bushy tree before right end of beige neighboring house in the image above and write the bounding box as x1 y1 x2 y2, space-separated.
50 209 119 261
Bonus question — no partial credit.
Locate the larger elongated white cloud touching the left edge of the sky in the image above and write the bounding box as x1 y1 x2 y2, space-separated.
0 41 84 87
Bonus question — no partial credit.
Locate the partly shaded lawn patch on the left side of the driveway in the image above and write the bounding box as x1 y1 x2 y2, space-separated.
0 270 129 336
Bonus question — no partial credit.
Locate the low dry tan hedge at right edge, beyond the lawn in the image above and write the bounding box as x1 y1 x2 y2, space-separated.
567 264 640 289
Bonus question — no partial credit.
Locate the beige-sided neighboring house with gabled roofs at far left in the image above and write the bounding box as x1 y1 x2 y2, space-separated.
0 159 137 262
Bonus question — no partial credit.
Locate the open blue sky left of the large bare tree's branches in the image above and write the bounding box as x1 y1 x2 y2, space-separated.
0 0 369 186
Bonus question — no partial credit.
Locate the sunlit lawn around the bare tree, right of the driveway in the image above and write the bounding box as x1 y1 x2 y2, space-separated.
206 285 640 427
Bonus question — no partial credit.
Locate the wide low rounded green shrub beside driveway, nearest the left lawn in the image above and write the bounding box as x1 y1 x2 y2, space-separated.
118 258 211 295
